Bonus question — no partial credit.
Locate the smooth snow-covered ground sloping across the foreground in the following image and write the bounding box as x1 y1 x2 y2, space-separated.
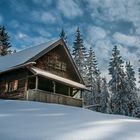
0 100 140 140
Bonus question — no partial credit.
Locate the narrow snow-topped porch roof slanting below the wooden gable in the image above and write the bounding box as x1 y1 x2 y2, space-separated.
30 67 88 90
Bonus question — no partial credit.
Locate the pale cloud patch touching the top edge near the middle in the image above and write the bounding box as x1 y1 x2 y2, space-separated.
58 0 83 19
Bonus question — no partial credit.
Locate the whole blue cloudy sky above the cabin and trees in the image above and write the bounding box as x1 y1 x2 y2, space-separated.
0 0 140 85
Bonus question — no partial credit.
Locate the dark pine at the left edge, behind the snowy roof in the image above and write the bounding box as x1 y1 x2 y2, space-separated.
0 26 11 56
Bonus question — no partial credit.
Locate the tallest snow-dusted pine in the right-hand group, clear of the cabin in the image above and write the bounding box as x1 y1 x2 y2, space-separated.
109 46 128 114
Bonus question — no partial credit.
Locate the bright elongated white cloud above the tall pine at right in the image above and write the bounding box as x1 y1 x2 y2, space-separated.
113 32 140 46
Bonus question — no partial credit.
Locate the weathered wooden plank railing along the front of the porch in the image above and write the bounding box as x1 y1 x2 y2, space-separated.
25 89 83 107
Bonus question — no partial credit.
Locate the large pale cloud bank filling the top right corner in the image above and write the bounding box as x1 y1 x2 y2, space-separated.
87 0 140 26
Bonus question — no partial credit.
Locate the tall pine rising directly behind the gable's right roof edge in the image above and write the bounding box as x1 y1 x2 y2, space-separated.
72 27 86 81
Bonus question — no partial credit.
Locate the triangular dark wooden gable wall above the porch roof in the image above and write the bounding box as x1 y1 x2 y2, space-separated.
35 45 80 82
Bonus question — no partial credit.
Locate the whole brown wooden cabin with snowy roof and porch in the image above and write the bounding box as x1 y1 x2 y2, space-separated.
0 39 87 107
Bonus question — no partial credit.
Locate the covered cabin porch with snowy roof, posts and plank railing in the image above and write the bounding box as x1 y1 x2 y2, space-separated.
25 67 86 107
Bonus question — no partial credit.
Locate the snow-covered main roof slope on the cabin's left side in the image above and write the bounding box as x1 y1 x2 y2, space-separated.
0 39 58 72
